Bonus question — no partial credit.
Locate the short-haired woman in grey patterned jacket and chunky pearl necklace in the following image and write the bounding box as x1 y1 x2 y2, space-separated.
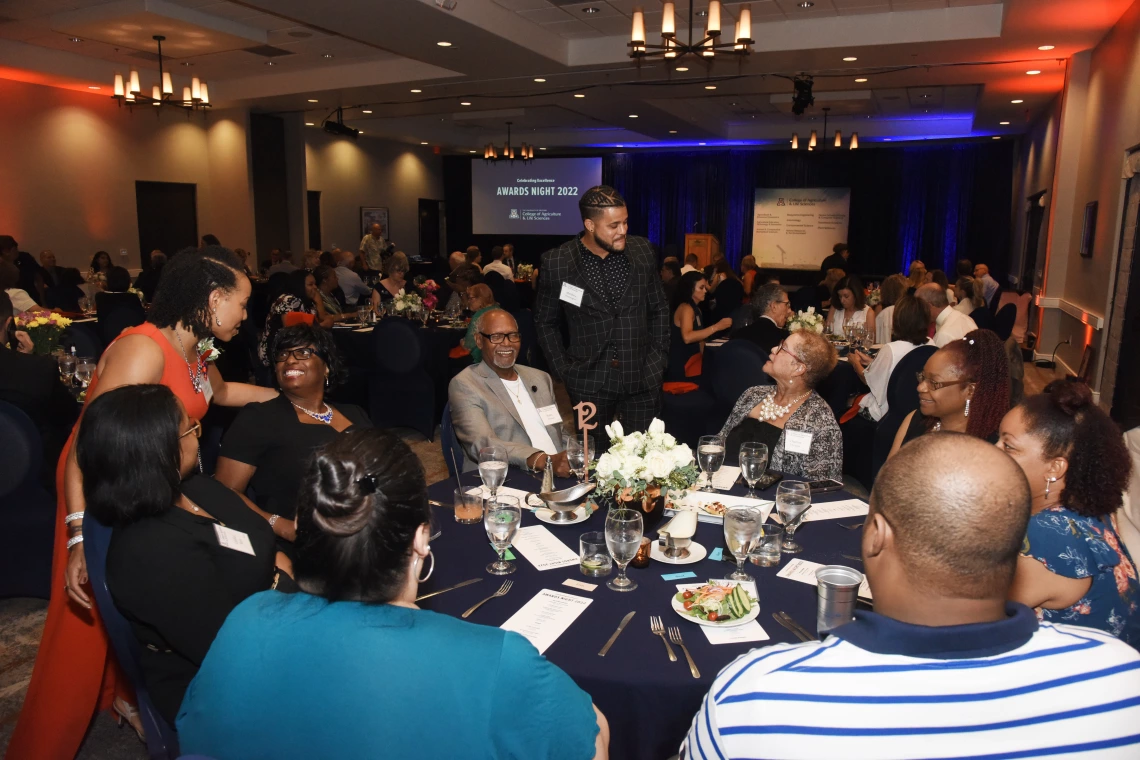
720 330 844 480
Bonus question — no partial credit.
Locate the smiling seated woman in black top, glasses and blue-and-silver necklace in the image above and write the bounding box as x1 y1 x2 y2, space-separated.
214 325 372 541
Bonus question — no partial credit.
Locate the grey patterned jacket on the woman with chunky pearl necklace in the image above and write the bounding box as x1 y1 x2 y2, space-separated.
720 385 844 481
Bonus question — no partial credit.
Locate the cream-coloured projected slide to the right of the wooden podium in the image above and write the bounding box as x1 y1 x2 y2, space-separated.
752 187 852 269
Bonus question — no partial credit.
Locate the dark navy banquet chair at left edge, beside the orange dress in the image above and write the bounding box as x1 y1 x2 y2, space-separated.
0 401 56 599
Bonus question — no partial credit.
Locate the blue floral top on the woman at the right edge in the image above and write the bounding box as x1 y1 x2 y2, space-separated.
1021 506 1140 646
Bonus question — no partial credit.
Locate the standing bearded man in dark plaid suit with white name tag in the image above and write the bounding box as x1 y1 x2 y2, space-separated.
535 185 669 433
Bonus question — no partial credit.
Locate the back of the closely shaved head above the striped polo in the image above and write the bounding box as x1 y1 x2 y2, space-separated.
864 433 1029 600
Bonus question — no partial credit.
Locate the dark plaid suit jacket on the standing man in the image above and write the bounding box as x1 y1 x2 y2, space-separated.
535 235 669 398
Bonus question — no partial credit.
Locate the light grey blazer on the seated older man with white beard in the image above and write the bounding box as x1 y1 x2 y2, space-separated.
447 361 562 472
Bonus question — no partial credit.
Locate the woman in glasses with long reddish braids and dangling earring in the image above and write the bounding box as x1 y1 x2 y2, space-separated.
888 330 1009 458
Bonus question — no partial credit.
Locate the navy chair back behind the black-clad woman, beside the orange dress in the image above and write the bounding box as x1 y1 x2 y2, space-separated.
83 515 178 760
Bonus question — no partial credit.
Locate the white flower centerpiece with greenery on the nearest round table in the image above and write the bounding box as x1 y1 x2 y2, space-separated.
592 418 700 517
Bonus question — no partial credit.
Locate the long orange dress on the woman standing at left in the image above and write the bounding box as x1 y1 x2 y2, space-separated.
5 322 210 760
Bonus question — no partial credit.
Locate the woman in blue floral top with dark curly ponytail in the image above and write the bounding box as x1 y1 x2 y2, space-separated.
998 379 1140 647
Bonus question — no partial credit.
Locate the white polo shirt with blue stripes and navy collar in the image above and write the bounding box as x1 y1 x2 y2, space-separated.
682 604 1140 760
